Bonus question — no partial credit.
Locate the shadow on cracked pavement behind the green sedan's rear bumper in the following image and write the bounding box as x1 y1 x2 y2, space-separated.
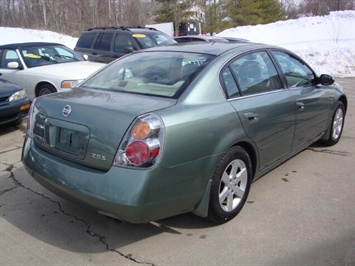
0 167 216 253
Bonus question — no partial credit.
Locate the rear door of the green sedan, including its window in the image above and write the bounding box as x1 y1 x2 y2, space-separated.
222 51 296 170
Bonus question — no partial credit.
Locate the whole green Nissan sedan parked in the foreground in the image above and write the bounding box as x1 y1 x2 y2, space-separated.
22 43 347 223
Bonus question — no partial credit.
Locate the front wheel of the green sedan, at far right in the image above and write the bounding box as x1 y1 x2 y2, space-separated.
321 102 345 146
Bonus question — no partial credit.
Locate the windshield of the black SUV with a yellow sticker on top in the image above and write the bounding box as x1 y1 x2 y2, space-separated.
132 31 176 49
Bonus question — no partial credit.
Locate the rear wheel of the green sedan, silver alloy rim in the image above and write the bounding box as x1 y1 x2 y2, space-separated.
208 146 252 224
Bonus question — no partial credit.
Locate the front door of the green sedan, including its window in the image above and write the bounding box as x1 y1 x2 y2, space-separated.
272 50 330 149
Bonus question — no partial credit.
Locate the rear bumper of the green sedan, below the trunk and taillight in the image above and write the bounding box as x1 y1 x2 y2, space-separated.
22 138 207 223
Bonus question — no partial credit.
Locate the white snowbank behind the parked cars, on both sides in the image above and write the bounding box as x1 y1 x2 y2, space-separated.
0 11 355 77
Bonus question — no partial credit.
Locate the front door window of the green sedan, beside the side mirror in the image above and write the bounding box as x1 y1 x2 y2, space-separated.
272 51 314 87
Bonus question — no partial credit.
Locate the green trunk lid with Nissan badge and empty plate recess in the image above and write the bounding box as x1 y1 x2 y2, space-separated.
33 89 176 170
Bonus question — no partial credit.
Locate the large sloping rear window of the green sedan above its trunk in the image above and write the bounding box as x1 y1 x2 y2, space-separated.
79 52 214 98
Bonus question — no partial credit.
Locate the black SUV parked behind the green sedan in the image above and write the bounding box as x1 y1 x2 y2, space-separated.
74 27 176 63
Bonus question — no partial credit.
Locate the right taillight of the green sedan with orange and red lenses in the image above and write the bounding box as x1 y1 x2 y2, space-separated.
113 114 164 167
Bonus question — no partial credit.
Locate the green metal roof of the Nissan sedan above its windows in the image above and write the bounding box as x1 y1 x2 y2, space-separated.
136 42 279 56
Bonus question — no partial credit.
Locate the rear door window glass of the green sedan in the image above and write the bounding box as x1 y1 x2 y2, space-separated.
230 52 282 95
